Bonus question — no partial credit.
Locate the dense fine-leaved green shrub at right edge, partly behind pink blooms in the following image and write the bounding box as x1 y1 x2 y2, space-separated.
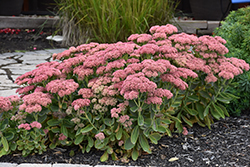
214 7 250 116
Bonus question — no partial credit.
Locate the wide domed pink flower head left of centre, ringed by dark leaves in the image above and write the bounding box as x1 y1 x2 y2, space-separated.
46 79 79 97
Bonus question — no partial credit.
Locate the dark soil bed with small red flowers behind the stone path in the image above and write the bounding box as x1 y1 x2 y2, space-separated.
0 28 63 54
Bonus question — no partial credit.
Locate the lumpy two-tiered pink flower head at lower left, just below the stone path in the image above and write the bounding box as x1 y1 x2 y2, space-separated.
19 92 52 114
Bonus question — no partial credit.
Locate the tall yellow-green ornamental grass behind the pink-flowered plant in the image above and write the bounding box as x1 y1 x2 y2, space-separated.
57 0 179 46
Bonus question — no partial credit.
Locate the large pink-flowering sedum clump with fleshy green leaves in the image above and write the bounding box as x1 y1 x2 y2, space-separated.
0 24 249 162
